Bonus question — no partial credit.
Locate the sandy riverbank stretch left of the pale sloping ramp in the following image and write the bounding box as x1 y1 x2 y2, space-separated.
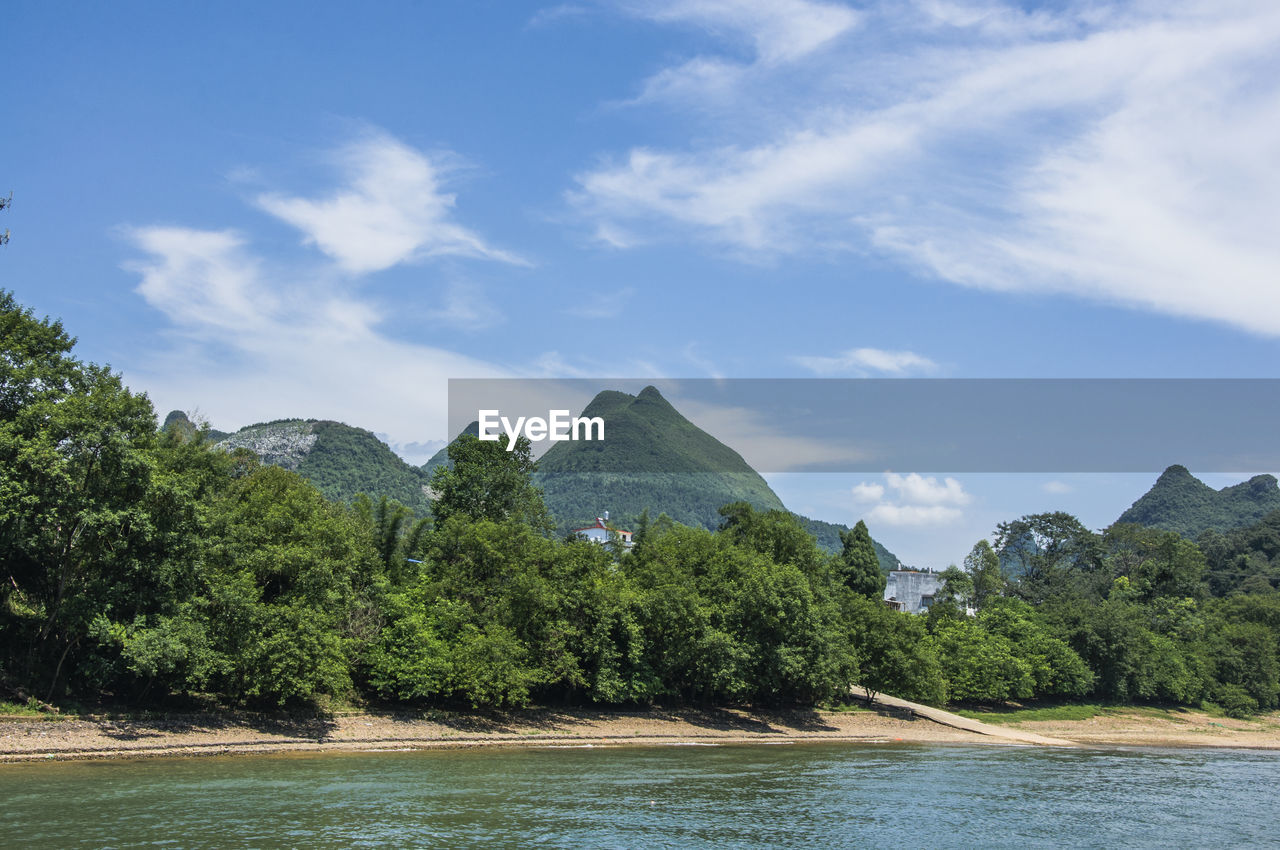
0 709 1008 762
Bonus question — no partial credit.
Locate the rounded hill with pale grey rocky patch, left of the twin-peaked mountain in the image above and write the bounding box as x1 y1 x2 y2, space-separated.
216 419 431 516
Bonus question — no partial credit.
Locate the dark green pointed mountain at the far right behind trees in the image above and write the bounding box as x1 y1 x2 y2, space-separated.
1117 466 1280 539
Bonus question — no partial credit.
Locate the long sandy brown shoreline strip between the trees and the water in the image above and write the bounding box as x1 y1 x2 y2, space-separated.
0 704 1280 764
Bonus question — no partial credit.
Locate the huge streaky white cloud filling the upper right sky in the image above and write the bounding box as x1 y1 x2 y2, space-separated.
581 0 1280 335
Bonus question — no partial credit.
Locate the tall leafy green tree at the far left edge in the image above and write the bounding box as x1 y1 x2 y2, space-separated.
0 291 172 698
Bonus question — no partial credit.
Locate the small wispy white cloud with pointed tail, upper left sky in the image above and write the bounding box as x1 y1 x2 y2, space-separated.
256 133 524 274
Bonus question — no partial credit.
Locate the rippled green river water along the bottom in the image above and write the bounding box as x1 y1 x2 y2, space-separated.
0 744 1280 850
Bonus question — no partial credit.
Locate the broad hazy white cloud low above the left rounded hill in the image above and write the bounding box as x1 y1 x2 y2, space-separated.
128 228 503 444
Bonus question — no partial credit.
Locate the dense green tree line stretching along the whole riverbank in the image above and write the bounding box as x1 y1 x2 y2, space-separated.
0 292 1280 713
